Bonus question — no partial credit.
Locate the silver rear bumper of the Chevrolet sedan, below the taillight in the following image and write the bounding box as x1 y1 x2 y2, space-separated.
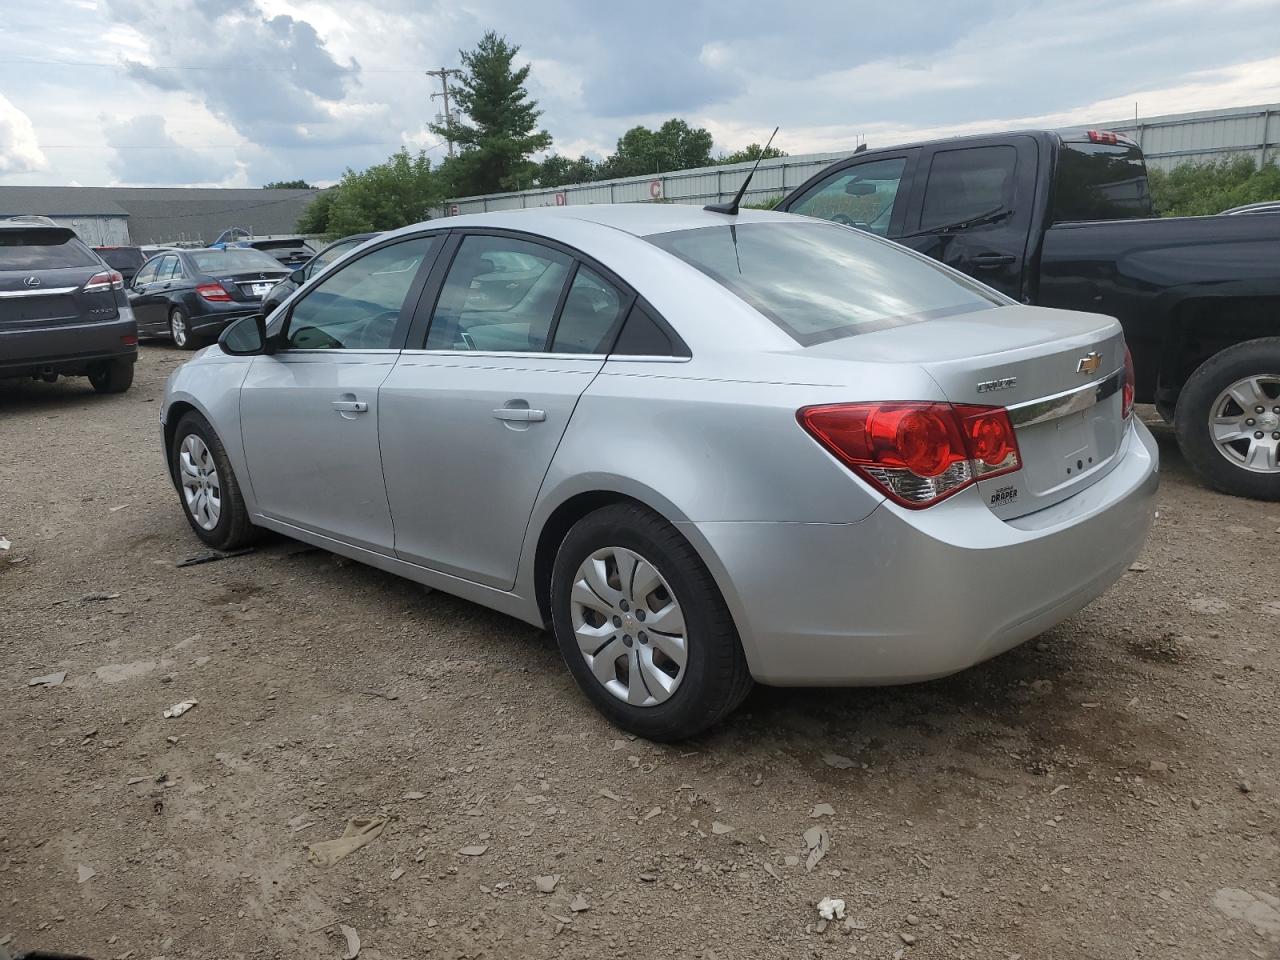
678 420 1158 686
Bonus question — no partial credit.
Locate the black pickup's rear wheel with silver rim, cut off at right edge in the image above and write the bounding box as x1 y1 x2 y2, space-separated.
1174 337 1280 500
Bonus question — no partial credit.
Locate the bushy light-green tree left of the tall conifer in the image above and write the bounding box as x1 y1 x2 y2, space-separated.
318 147 444 238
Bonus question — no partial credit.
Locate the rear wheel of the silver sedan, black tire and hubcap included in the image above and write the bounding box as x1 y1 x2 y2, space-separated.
550 503 751 741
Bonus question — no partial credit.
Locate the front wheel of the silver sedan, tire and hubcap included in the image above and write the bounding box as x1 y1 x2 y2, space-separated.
169 412 260 550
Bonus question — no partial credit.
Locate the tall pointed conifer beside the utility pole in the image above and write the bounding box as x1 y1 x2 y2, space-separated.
431 31 552 196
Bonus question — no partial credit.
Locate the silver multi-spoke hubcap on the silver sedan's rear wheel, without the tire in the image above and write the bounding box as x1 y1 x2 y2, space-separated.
570 547 689 707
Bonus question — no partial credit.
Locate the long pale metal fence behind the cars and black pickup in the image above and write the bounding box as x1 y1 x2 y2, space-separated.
438 104 1280 216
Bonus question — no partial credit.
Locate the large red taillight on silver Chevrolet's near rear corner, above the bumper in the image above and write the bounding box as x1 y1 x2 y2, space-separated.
796 402 1021 508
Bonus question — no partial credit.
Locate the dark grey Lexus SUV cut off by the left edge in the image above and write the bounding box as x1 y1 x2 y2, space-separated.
0 216 138 393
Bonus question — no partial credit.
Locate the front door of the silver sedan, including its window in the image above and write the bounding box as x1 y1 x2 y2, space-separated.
241 237 440 554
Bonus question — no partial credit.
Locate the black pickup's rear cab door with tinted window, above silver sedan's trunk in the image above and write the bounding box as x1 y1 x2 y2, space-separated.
891 136 1038 301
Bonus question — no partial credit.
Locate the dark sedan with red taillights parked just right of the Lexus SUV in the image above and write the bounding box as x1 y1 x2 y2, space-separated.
129 247 288 349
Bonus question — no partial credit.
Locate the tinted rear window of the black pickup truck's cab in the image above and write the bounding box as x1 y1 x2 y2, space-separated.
1053 141 1152 223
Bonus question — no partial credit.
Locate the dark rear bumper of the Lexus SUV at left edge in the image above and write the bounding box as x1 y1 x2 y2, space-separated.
0 311 138 378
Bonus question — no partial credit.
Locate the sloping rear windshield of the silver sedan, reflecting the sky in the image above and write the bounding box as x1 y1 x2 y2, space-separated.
646 223 1007 346
